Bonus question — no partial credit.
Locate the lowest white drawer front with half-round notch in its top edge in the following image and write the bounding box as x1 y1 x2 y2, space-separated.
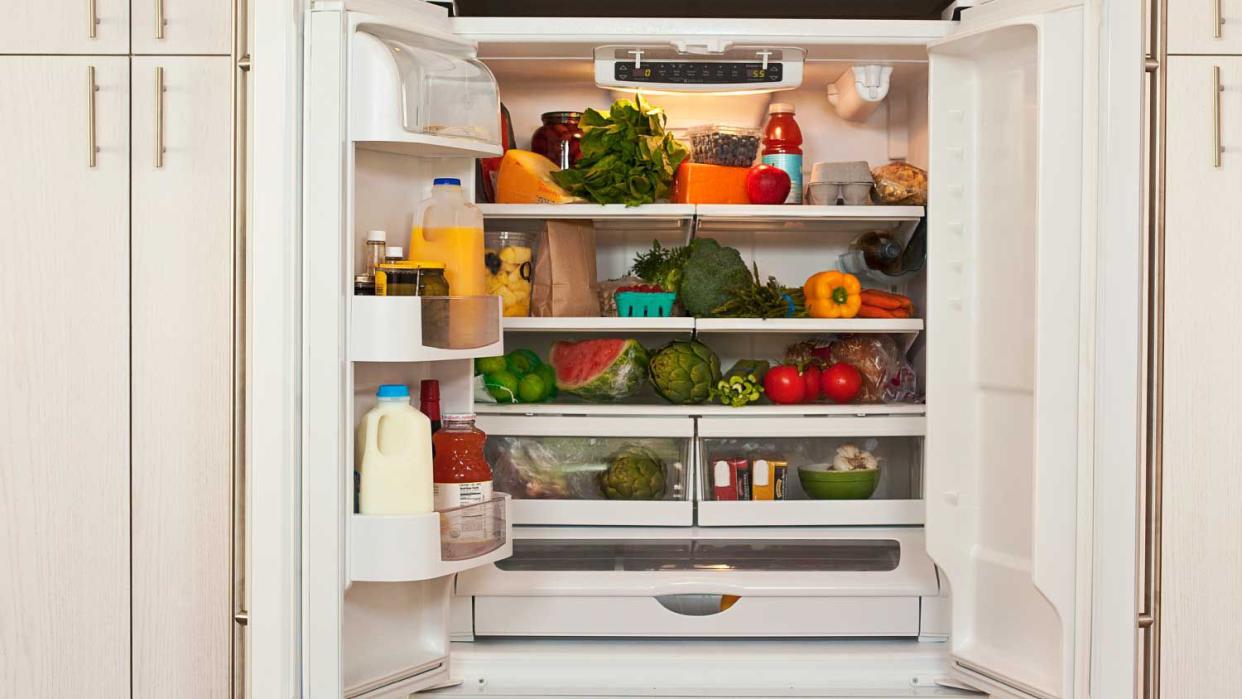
474 595 919 637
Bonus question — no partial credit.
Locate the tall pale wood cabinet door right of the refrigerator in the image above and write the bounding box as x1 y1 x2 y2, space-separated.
1160 54 1242 697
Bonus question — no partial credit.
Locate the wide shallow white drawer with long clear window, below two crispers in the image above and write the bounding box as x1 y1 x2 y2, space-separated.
457 528 939 597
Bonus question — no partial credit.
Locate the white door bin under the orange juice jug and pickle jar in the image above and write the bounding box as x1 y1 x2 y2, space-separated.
349 295 504 361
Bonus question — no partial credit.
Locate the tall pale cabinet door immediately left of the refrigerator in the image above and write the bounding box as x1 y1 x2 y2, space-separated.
133 56 233 698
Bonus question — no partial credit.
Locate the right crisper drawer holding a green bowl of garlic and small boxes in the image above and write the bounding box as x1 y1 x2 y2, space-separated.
696 416 925 526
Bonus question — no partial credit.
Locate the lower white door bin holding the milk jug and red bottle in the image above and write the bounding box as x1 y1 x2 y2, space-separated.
348 493 513 582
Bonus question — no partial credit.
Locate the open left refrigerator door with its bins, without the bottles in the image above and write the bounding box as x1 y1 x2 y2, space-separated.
299 0 513 698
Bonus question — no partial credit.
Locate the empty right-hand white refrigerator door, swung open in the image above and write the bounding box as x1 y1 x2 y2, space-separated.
925 0 1093 698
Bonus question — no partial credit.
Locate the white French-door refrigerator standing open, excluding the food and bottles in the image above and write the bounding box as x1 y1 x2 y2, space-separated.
299 0 1141 698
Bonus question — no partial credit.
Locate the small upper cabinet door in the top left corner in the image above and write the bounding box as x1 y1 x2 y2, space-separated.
0 0 129 55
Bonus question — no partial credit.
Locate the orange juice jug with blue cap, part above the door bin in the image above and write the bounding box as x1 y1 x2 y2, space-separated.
410 178 487 295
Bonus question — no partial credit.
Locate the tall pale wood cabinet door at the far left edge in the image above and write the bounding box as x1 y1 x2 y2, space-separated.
0 56 129 699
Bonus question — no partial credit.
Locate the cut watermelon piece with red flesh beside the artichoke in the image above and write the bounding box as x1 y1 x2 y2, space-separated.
549 338 647 401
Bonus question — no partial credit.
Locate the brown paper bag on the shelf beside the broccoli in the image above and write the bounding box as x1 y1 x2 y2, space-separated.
530 221 600 317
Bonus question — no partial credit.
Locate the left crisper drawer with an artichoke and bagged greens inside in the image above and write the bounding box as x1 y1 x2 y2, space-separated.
478 415 694 526
